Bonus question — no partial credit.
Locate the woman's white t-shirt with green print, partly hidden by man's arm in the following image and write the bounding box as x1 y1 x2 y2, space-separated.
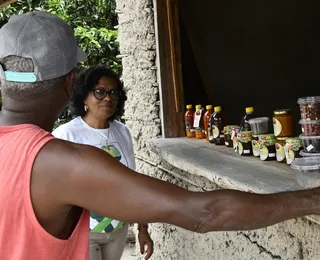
52 117 136 233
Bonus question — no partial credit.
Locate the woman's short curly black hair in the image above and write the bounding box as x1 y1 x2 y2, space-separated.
70 66 127 121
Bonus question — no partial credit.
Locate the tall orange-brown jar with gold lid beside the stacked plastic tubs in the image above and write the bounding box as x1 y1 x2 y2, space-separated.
273 109 294 137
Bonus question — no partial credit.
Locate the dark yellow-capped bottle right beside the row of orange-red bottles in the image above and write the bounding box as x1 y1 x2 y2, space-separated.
209 106 226 145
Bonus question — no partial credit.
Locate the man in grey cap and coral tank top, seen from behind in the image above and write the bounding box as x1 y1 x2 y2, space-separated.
0 12 320 260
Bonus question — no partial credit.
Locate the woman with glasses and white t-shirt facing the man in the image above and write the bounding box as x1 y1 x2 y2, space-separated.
53 67 153 260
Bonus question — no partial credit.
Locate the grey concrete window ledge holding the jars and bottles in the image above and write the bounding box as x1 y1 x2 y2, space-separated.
150 138 320 224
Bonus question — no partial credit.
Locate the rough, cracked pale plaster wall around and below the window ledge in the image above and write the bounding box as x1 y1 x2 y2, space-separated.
117 0 320 260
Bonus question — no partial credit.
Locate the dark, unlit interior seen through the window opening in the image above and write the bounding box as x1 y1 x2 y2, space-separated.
179 0 320 134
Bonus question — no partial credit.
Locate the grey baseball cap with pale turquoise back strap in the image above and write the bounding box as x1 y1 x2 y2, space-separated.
0 12 86 82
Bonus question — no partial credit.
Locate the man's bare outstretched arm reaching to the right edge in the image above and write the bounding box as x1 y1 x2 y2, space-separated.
33 140 320 232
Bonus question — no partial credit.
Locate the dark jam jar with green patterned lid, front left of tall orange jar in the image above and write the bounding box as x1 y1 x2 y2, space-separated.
259 134 276 161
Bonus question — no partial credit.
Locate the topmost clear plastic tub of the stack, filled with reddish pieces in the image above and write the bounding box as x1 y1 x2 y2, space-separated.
298 96 320 120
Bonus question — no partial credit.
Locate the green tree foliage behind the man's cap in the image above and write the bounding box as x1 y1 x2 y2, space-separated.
0 0 121 73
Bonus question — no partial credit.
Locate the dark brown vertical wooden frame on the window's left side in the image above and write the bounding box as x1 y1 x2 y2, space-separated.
154 0 185 138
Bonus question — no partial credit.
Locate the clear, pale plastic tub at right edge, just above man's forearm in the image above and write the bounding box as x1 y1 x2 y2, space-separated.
291 157 320 188
